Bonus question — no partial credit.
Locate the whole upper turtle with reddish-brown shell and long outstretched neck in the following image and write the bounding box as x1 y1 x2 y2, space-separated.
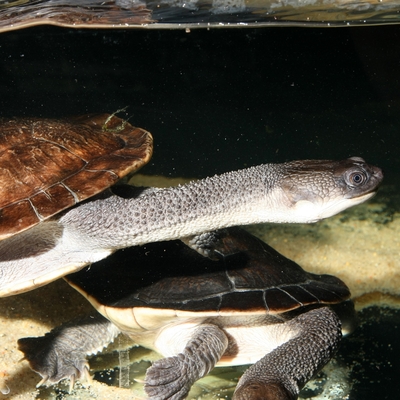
0 112 383 297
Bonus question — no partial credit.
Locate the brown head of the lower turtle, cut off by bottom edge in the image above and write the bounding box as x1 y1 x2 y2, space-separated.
232 381 297 400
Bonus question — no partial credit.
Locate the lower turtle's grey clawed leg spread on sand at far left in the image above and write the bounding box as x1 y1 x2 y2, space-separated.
18 312 120 388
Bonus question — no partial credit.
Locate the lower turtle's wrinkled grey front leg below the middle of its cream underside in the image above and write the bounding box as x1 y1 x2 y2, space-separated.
145 325 228 400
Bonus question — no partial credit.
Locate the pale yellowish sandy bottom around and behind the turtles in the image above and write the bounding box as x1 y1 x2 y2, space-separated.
0 175 400 399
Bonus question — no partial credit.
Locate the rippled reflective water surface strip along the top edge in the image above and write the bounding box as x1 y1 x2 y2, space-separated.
0 0 400 28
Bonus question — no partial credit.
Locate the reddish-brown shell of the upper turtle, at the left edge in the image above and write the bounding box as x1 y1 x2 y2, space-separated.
0 114 153 240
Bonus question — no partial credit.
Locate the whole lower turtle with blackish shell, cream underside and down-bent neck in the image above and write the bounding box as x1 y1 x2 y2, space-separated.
19 228 353 400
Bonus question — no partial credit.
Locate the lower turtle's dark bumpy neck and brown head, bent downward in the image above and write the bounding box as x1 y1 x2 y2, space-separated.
233 307 342 400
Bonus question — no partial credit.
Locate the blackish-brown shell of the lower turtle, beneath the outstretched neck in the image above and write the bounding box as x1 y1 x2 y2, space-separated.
65 228 350 315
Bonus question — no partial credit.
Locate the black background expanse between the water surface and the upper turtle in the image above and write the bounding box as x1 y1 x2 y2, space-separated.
0 26 400 182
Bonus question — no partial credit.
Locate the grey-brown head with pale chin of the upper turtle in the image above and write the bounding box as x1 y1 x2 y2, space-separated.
280 157 383 222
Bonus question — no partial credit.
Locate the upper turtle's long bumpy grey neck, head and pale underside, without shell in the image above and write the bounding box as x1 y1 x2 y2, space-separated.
0 153 383 296
